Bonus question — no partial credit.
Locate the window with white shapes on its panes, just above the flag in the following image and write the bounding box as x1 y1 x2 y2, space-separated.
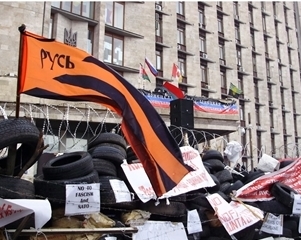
104 33 123 65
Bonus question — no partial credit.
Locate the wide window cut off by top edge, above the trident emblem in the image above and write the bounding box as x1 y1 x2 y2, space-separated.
51 1 95 19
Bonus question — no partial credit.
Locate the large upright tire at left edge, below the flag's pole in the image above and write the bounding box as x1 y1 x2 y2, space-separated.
0 118 40 175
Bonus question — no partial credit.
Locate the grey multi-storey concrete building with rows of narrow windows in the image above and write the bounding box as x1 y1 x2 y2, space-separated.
0 1 301 169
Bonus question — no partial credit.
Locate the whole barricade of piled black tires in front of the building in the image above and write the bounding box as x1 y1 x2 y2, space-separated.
0 119 300 240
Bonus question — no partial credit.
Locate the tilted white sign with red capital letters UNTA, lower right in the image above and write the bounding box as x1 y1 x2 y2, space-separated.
207 193 263 235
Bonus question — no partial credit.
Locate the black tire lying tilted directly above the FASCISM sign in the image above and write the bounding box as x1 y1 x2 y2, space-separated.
42 152 94 180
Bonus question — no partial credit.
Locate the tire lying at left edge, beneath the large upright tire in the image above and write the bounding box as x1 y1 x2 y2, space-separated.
0 175 36 199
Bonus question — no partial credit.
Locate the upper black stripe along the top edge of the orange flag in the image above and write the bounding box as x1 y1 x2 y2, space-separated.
83 57 185 165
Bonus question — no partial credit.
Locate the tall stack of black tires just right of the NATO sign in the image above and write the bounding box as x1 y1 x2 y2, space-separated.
88 132 136 210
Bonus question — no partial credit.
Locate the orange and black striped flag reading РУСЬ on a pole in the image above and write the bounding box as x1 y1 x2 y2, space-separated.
18 31 192 196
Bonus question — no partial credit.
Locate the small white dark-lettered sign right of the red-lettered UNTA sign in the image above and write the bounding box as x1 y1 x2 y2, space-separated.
260 213 283 235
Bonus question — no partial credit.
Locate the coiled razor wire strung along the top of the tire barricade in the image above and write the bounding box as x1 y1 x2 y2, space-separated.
0 102 301 162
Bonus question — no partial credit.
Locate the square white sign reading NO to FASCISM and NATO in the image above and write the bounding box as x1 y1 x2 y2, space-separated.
65 183 100 216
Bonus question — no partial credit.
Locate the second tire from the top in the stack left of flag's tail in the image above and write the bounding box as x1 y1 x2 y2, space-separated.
89 146 126 166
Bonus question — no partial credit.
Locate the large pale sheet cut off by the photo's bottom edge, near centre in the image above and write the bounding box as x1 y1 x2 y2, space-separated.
133 221 188 240
